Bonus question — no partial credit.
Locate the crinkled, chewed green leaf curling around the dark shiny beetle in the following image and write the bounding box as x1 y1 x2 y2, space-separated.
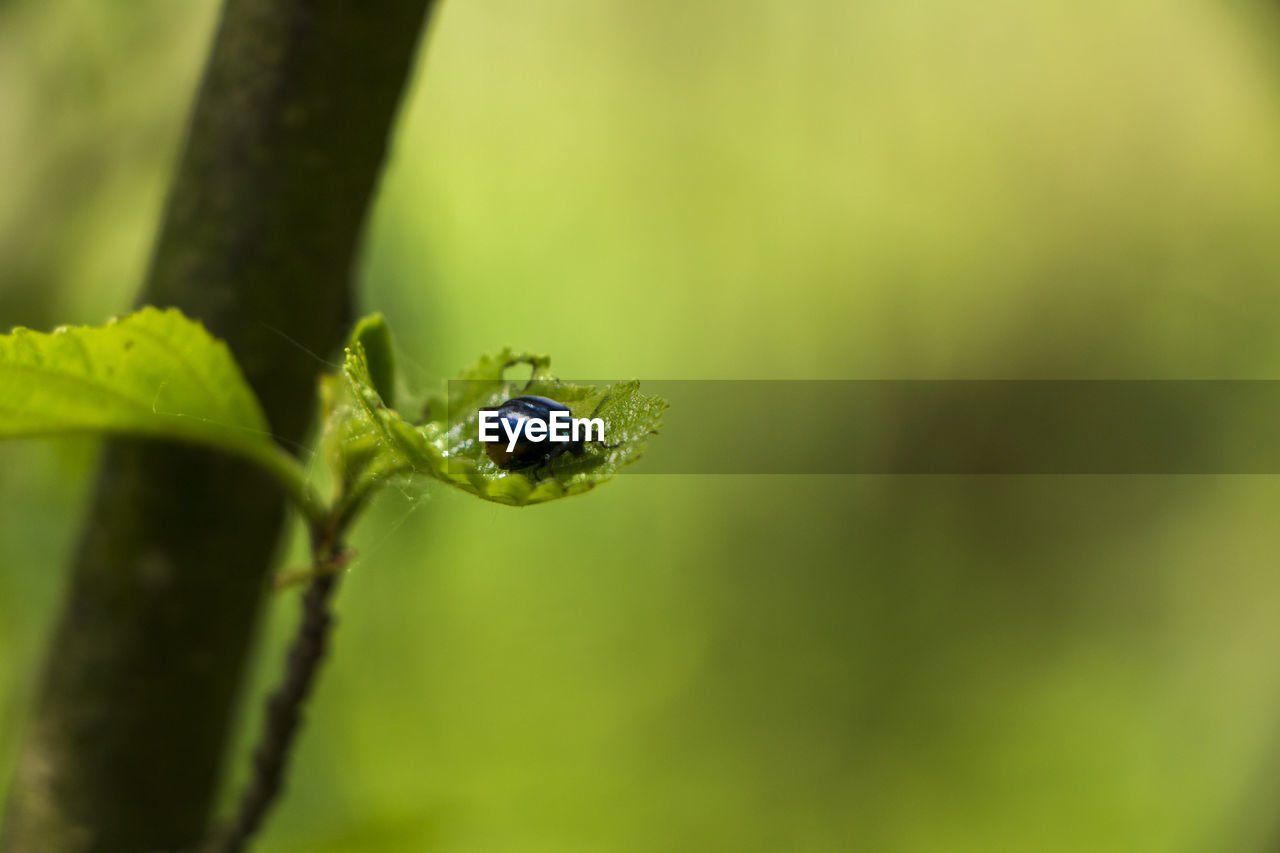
326 338 667 506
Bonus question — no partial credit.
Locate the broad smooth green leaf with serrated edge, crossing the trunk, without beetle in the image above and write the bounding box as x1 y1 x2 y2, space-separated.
0 307 315 512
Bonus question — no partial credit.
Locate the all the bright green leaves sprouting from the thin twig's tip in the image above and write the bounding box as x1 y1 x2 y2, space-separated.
0 307 667 514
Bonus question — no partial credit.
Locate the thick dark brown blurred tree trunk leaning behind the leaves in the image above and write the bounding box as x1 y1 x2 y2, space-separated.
3 0 431 853
